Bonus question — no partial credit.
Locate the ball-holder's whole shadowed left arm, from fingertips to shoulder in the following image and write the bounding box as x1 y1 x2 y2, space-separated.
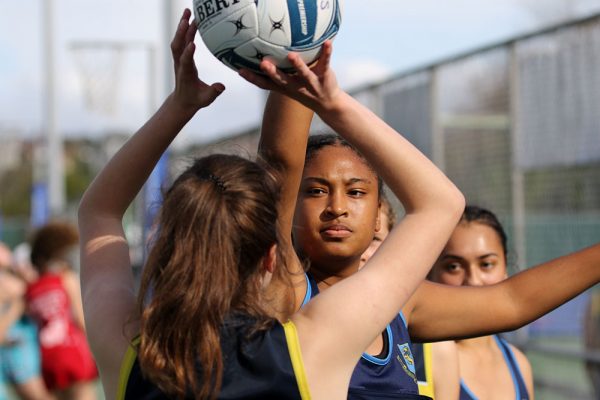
79 10 224 394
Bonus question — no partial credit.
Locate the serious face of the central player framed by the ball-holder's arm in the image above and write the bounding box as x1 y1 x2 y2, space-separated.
294 146 379 270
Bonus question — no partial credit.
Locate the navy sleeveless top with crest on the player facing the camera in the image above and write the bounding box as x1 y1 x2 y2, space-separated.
302 274 429 400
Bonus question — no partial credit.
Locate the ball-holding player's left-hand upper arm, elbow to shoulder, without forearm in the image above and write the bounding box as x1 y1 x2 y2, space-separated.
79 215 138 375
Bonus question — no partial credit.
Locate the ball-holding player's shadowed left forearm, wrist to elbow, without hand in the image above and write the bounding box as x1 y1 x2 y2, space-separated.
79 96 195 217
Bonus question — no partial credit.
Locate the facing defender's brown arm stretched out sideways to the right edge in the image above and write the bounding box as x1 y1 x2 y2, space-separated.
404 244 600 340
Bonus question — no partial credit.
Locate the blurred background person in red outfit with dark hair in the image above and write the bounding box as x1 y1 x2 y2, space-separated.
26 222 98 400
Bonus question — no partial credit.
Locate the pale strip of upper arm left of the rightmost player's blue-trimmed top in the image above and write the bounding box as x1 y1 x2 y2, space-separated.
431 340 460 400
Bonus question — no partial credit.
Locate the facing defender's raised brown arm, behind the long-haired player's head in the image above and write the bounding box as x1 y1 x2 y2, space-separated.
258 92 313 310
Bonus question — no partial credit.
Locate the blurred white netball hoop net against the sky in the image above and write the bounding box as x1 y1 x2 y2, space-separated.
70 42 124 116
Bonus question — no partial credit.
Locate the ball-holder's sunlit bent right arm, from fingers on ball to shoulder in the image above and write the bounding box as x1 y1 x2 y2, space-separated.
241 42 464 398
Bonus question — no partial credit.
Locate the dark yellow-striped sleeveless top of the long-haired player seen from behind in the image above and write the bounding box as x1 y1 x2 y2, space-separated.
116 316 310 400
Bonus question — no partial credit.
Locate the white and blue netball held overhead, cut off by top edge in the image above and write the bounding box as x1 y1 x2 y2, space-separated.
194 0 342 72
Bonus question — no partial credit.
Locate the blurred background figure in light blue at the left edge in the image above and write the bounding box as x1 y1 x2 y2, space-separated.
0 242 51 400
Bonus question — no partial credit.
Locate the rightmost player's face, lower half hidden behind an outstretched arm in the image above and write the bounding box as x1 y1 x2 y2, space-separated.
430 222 507 286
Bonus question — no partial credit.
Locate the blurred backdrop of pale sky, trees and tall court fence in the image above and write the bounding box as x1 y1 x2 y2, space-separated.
0 0 600 399
